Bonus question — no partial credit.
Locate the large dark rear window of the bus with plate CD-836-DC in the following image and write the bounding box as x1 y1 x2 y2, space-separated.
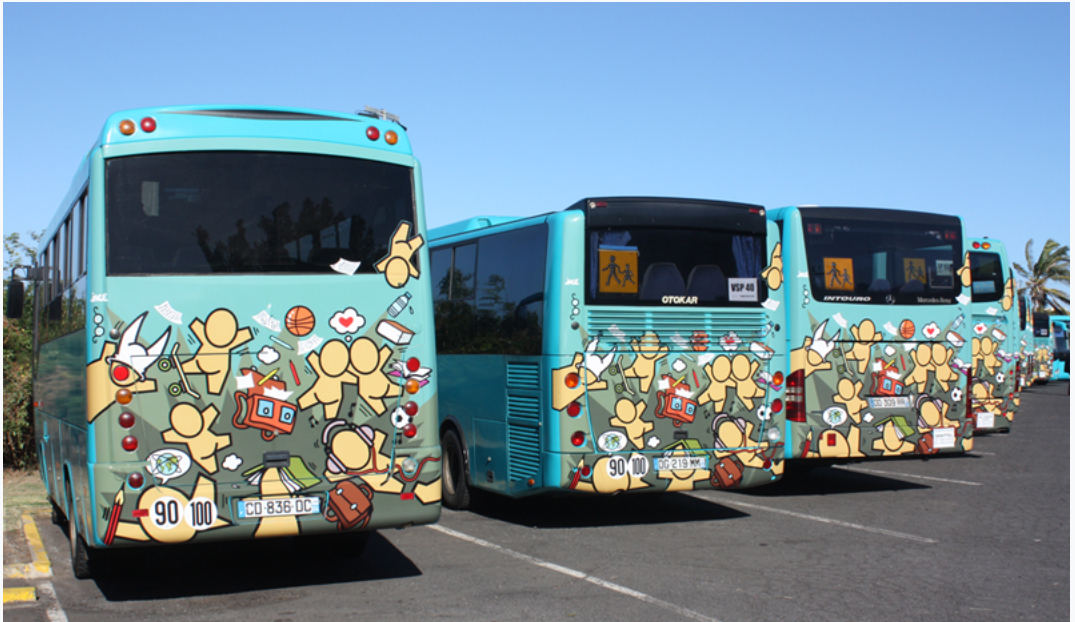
105 151 415 275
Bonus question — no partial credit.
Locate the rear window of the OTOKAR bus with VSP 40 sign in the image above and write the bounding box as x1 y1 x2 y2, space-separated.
586 227 768 306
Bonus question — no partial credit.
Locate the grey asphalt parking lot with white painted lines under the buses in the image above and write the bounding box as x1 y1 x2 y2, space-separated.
4 381 1071 622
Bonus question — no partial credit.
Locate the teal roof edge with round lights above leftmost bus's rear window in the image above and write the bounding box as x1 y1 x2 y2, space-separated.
95 105 412 155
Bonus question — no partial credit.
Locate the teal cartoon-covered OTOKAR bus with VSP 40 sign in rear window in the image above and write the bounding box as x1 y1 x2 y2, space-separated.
430 198 786 509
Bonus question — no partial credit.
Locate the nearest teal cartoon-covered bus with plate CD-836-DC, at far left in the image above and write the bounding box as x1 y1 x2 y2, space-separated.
10 106 441 578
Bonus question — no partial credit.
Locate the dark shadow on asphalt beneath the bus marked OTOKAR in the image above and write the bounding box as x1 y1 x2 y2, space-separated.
470 490 749 530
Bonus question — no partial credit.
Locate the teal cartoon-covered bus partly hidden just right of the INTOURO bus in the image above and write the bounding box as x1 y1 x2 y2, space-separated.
965 237 1020 433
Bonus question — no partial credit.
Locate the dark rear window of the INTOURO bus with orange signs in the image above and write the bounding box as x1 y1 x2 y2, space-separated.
803 214 962 304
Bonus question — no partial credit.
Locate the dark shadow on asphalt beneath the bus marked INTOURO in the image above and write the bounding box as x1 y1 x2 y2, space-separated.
732 465 932 496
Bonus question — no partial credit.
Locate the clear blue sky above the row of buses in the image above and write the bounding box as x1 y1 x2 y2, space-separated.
3 3 1071 281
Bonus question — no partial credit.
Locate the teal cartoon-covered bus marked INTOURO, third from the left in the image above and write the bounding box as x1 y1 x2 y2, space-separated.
769 206 973 468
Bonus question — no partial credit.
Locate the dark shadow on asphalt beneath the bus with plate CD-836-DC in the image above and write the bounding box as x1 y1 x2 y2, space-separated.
94 532 421 602
